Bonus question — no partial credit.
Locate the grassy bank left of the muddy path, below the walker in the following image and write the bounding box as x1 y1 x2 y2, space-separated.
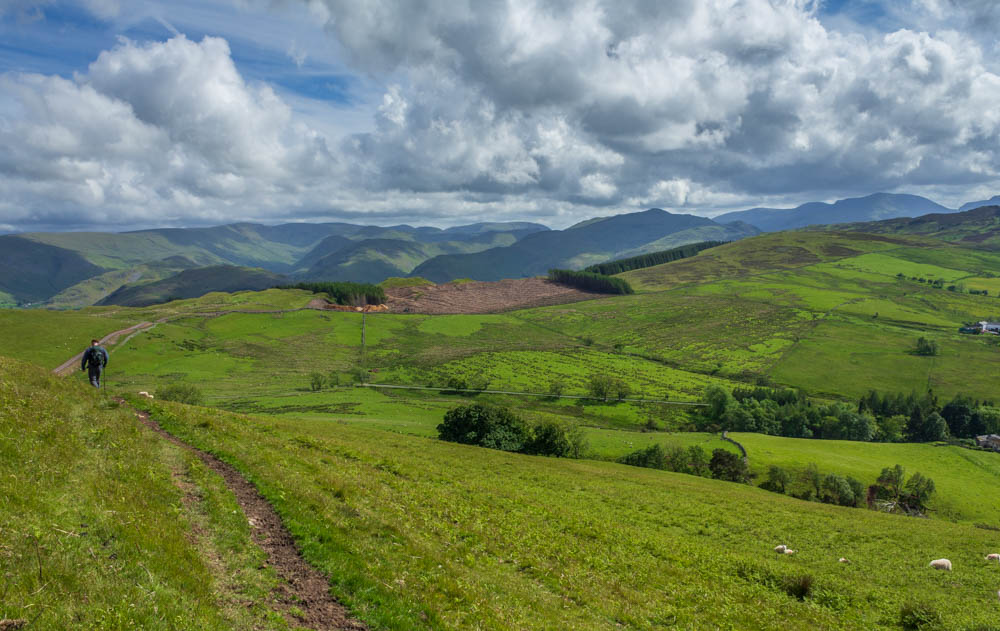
0 357 288 630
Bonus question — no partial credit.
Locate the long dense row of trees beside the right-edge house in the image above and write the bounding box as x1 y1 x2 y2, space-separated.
702 385 1000 442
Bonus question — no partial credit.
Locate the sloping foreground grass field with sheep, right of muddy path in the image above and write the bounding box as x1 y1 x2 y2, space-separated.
133 404 998 629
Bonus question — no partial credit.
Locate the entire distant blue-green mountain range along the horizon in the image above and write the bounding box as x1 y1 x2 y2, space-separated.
0 193 1000 308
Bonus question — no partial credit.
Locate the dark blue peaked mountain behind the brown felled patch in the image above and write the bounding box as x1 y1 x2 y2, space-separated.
412 208 749 282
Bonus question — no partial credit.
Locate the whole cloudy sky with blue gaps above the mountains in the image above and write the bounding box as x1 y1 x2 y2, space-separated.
0 0 1000 232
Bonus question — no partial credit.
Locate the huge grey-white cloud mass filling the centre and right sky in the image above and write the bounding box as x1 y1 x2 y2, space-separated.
302 0 1000 212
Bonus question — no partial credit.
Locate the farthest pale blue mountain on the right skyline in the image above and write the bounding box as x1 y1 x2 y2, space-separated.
714 193 952 232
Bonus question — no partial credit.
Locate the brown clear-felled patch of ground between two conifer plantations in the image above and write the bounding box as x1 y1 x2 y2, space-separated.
385 278 607 314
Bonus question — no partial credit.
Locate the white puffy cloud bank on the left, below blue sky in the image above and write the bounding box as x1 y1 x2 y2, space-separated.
0 37 337 230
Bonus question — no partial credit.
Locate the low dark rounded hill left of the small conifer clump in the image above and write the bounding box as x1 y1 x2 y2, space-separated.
97 265 288 307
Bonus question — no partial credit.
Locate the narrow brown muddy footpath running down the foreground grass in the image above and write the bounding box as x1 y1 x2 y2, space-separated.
116 399 368 631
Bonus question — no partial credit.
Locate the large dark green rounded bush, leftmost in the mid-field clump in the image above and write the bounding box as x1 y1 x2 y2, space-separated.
437 403 530 451
